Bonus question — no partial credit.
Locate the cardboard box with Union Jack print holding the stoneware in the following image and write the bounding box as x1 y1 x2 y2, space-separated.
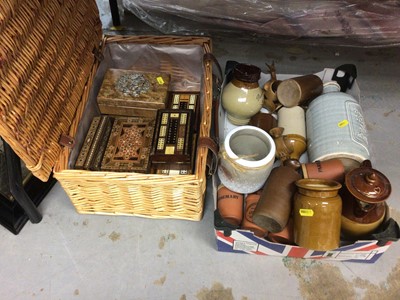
213 69 397 263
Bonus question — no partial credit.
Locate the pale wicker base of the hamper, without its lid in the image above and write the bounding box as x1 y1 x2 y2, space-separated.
54 36 212 221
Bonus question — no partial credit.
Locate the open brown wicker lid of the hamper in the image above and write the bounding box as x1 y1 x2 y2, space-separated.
0 0 102 181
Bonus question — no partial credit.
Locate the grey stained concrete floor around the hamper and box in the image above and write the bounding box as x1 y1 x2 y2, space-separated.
0 1 400 300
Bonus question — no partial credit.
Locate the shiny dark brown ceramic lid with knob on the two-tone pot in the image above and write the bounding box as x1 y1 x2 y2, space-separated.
346 161 392 203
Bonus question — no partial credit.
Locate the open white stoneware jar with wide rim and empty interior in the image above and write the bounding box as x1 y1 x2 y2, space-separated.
218 125 275 194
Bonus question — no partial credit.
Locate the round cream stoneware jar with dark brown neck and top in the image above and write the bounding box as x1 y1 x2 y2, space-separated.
221 64 264 125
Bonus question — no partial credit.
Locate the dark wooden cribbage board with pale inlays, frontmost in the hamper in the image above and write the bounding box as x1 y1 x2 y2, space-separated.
151 109 193 168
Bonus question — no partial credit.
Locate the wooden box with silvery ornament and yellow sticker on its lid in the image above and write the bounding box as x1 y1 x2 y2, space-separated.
97 68 171 117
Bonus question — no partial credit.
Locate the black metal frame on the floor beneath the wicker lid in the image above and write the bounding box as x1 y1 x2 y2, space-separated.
0 141 56 234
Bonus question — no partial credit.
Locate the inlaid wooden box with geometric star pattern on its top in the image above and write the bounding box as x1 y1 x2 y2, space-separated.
101 117 155 173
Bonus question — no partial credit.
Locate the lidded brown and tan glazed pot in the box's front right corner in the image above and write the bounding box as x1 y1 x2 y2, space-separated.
341 160 391 239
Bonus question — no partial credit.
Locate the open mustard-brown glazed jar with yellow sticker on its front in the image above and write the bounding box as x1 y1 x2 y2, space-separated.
293 179 342 251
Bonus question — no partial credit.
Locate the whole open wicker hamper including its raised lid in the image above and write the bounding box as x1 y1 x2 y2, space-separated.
0 0 216 220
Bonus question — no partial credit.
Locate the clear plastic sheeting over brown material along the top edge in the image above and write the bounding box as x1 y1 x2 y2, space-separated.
123 0 400 47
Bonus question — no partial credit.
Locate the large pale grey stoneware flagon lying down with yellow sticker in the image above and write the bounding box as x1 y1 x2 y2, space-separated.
306 82 370 172
